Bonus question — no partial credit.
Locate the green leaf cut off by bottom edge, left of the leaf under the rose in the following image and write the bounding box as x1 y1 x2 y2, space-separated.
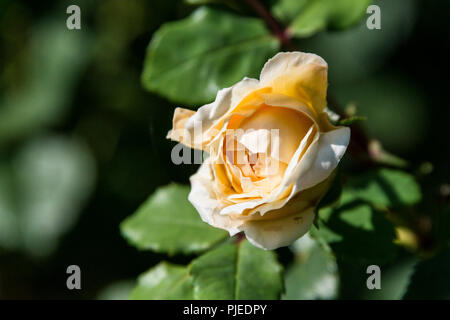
129 262 193 300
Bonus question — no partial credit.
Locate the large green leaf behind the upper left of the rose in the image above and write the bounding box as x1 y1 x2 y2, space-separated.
142 7 280 105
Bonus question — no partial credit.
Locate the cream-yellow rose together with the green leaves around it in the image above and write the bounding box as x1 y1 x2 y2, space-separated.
121 0 436 299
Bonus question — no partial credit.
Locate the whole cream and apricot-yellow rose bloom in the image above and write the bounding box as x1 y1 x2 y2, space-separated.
168 52 350 249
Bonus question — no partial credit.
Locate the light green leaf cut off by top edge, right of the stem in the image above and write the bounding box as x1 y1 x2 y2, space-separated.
272 0 371 37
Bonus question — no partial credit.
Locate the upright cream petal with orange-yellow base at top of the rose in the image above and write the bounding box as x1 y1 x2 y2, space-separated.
260 52 328 114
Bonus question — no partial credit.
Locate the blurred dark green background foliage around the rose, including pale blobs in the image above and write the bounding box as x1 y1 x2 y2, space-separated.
0 0 450 299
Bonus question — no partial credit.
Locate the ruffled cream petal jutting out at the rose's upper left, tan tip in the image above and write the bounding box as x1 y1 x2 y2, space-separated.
167 78 260 149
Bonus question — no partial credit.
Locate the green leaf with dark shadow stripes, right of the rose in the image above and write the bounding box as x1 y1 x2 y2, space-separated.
342 168 422 207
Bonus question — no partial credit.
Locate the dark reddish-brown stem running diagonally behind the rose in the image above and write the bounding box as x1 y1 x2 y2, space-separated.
246 0 378 166
